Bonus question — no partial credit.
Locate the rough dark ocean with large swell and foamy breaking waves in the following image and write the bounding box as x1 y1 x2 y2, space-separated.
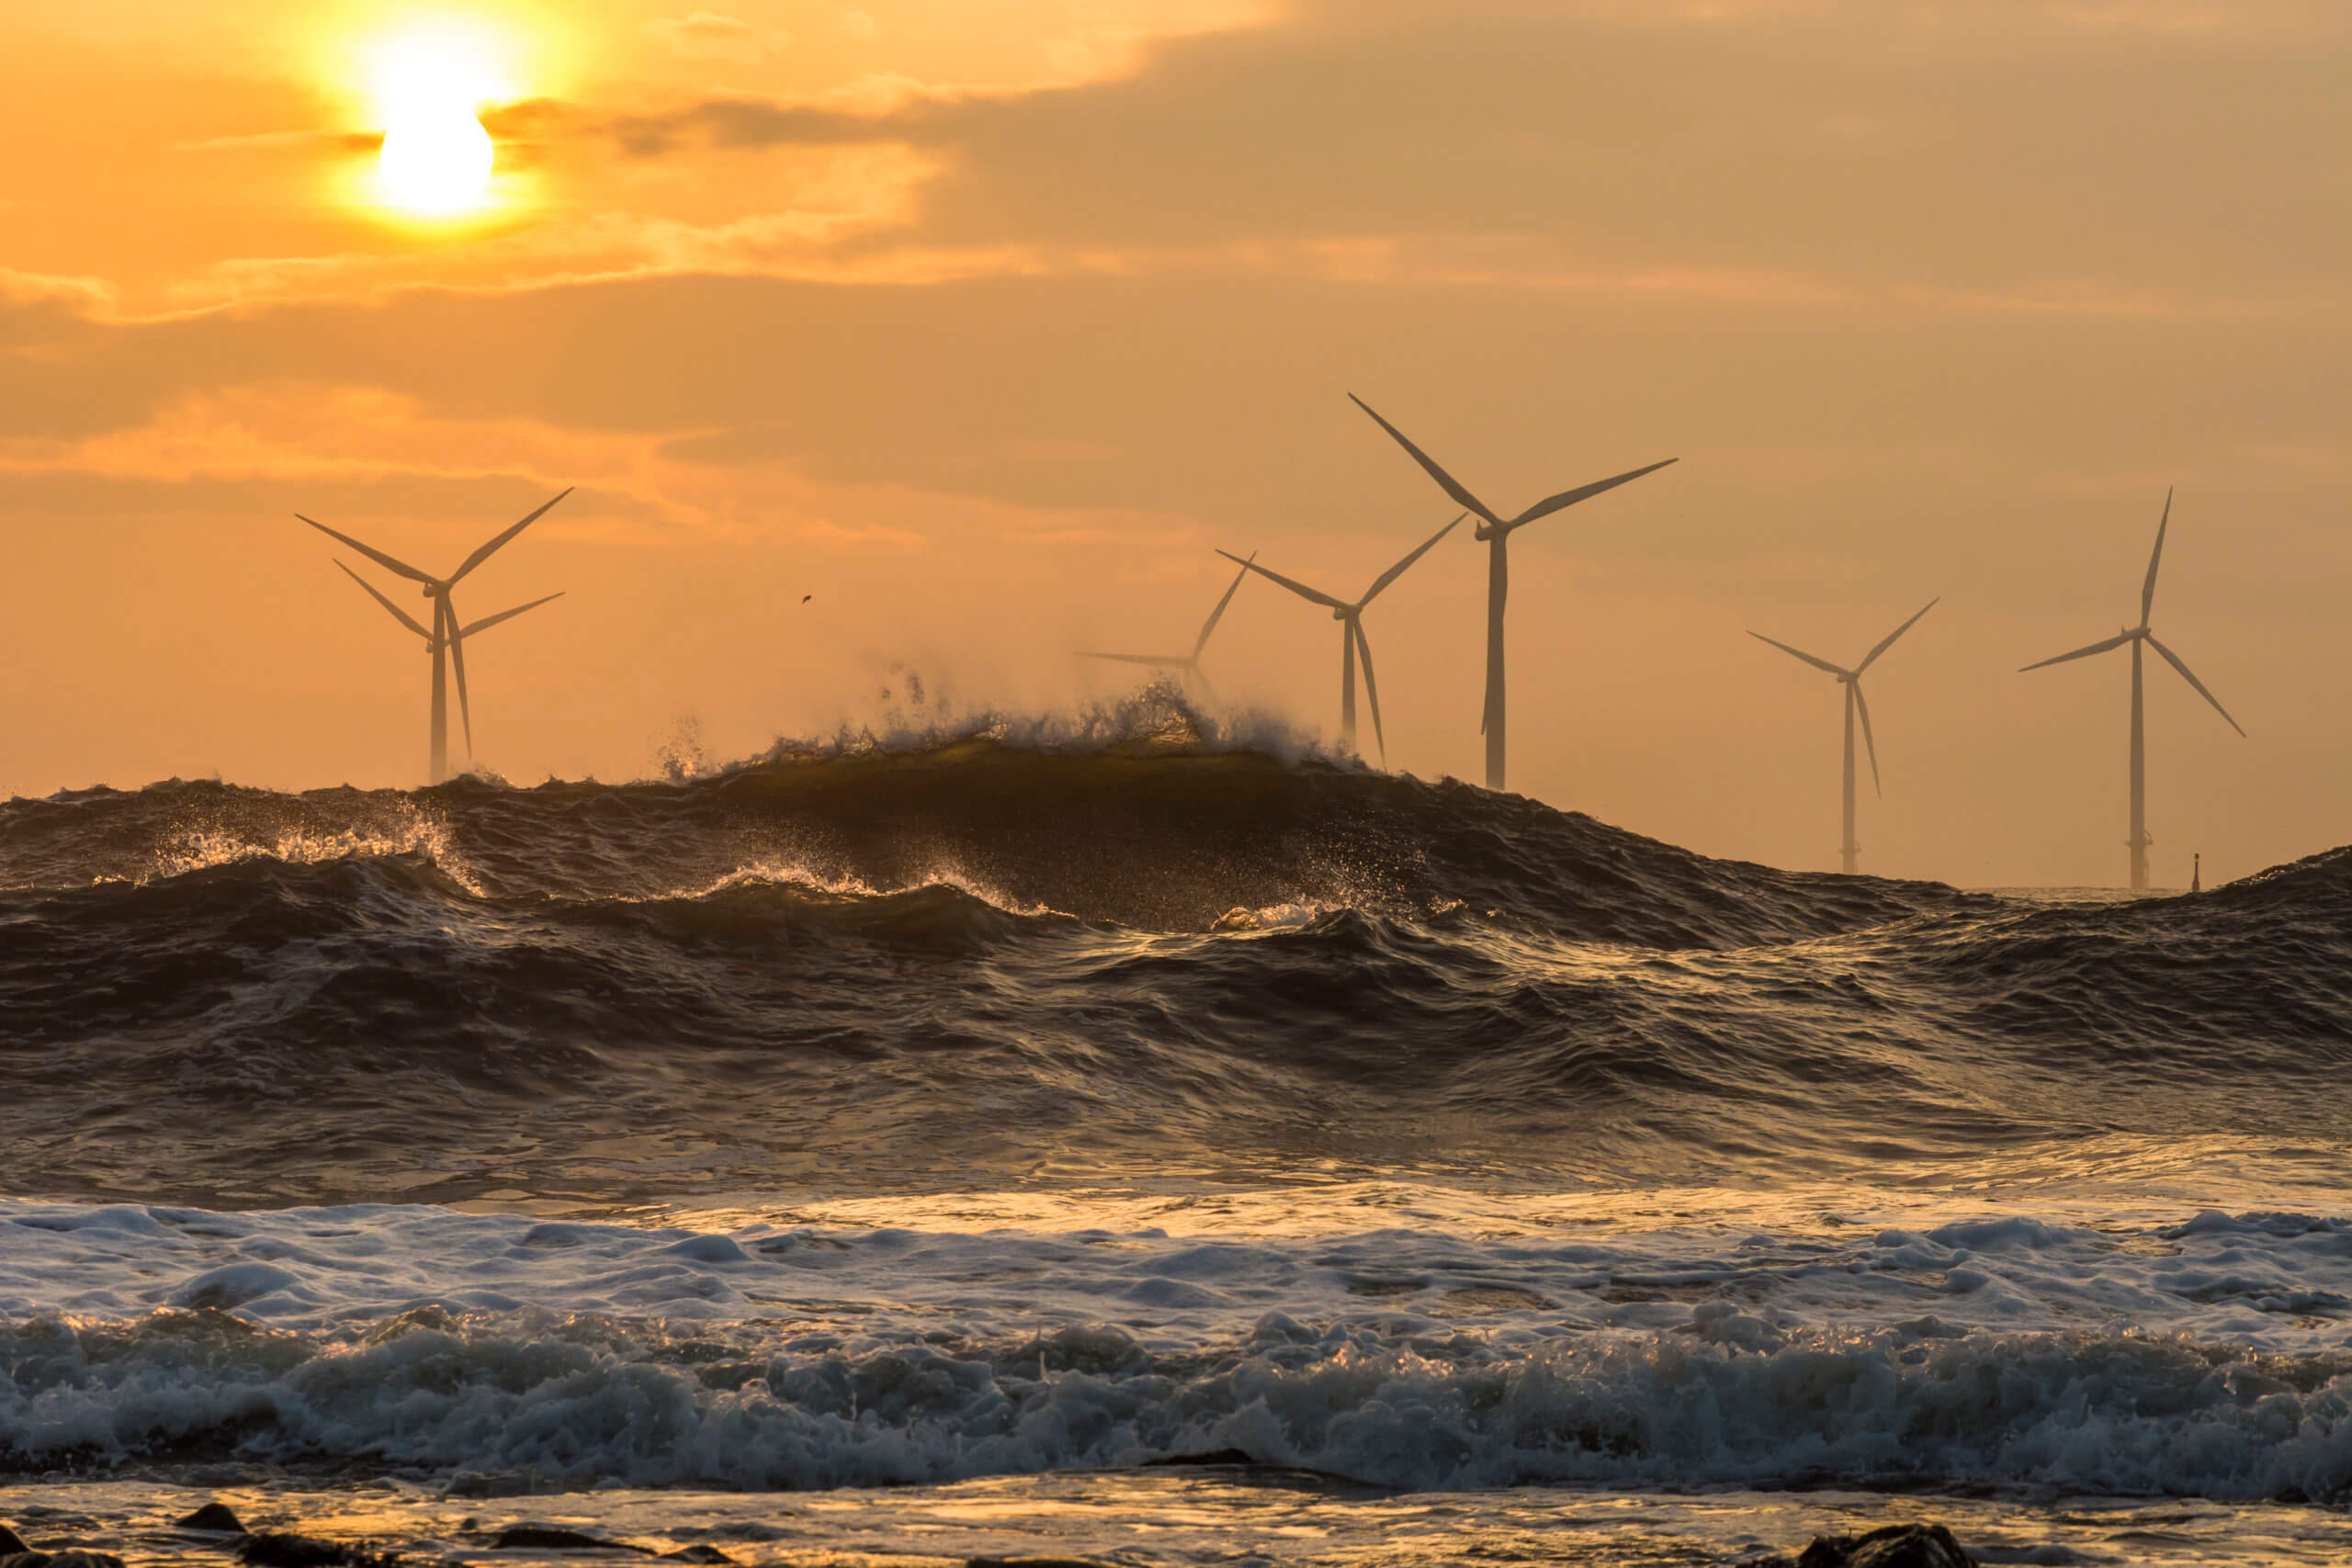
0 710 2352 1568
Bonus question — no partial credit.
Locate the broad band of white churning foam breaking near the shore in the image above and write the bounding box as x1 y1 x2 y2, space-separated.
0 1203 2352 1497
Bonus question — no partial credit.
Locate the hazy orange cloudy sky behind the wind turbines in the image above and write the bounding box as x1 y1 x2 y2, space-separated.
0 0 2352 884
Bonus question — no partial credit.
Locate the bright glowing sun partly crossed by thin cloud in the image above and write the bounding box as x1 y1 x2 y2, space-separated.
369 28 505 219
